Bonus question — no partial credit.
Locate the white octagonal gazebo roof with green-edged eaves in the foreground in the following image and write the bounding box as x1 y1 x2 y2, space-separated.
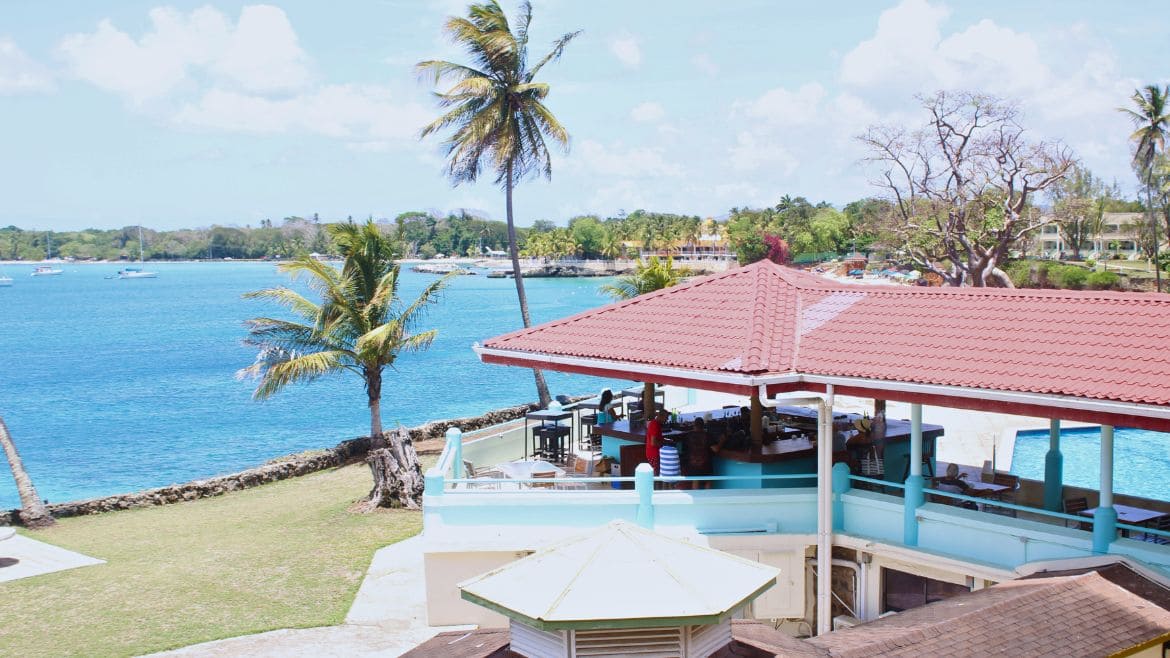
460 521 779 631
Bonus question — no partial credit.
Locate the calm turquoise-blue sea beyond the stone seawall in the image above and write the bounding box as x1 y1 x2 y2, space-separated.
0 262 622 509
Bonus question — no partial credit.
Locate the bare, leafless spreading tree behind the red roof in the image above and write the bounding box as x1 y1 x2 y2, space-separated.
859 91 1074 287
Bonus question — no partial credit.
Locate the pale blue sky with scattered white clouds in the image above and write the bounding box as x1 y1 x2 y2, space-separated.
0 0 1170 229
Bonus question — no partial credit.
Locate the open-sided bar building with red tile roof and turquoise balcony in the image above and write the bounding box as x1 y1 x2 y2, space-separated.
424 261 1170 635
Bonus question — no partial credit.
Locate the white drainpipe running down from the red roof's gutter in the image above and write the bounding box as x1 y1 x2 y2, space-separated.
758 384 833 635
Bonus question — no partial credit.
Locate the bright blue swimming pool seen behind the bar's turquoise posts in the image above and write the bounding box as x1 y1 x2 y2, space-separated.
1012 427 1170 500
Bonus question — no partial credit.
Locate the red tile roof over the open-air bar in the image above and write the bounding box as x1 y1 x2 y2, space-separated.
484 261 1170 416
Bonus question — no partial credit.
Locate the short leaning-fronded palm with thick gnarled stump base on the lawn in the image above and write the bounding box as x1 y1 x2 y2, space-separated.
238 221 450 508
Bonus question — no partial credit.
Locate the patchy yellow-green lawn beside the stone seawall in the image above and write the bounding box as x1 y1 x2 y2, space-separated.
0 465 422 657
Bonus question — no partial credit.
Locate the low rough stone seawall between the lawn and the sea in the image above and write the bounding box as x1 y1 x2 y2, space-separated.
0 404 537 526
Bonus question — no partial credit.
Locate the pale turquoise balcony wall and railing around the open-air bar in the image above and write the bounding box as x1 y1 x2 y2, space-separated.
424 426 1170 573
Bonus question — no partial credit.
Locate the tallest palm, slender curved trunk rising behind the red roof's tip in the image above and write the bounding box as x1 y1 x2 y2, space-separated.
417 0 580 406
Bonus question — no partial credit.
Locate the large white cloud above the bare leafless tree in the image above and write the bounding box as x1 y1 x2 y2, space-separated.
840 0 1140 189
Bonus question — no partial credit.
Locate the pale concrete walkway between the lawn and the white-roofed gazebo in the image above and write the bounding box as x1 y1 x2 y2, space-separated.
152 537 472 658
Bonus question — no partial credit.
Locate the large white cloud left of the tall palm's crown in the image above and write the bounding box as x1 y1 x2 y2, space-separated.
59 5 431 145
